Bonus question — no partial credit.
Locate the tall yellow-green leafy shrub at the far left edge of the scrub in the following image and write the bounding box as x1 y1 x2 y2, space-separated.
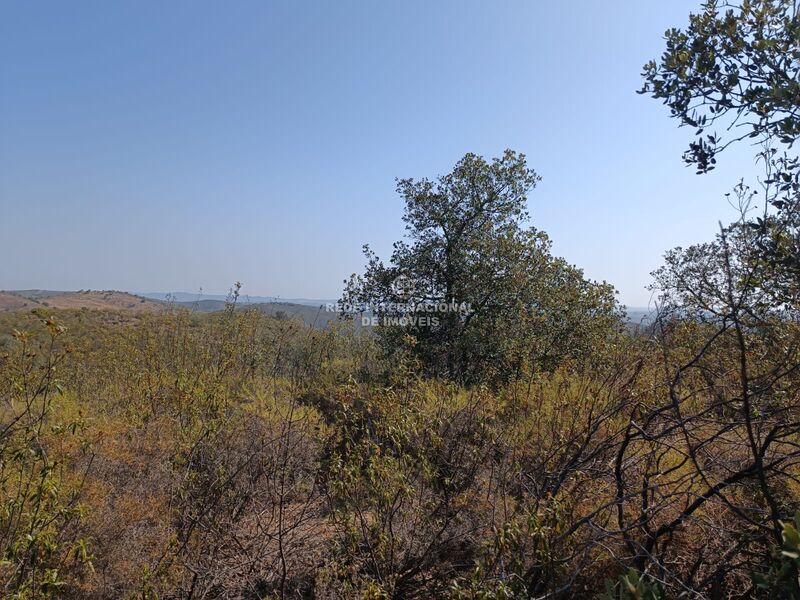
0 318 91 600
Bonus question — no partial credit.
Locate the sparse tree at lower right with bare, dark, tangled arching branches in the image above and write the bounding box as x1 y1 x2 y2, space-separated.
640 218 800 598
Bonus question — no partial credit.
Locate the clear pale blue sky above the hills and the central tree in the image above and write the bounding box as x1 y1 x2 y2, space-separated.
0 0 756 306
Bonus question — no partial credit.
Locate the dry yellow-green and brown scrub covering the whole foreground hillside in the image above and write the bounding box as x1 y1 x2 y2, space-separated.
0 298 800 598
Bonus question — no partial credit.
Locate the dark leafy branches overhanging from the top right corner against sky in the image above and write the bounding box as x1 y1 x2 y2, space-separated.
641 0 800 303
